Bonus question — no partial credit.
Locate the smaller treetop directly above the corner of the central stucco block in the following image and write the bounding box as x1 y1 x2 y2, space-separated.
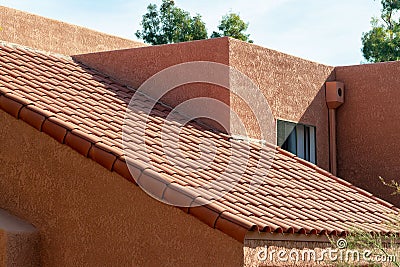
211 13 253 43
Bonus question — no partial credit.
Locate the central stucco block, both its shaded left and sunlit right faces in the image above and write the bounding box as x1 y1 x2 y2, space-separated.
73 37 335 174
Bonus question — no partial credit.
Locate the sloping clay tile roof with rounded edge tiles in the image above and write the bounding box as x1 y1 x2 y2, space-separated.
0 43 398 241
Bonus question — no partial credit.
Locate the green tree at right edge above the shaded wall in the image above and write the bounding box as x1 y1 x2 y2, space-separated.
362 0 400 62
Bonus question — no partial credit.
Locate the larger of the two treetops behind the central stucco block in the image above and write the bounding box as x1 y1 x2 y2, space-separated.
136 0 207 45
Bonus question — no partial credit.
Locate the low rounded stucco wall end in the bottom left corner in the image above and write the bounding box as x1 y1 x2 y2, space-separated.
0 209 40 267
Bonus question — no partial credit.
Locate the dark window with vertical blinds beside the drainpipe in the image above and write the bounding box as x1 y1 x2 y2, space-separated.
277 120 317 164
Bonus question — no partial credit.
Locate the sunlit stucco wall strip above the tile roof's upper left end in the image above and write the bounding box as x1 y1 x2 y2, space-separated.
0 6 147 55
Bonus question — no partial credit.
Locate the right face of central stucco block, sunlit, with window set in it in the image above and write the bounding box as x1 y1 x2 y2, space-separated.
229 39 334 170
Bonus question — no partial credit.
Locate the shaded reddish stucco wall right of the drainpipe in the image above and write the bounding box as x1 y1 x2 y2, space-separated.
336 62 400 207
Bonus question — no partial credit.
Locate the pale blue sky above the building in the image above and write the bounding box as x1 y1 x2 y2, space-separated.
0 0 380 66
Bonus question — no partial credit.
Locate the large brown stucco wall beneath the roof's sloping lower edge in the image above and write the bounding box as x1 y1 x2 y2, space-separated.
0 111 243 266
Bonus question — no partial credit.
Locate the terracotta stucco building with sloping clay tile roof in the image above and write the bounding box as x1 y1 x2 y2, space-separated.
0 7 400 266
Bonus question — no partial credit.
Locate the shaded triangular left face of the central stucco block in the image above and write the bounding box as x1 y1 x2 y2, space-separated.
73 38 229 131
